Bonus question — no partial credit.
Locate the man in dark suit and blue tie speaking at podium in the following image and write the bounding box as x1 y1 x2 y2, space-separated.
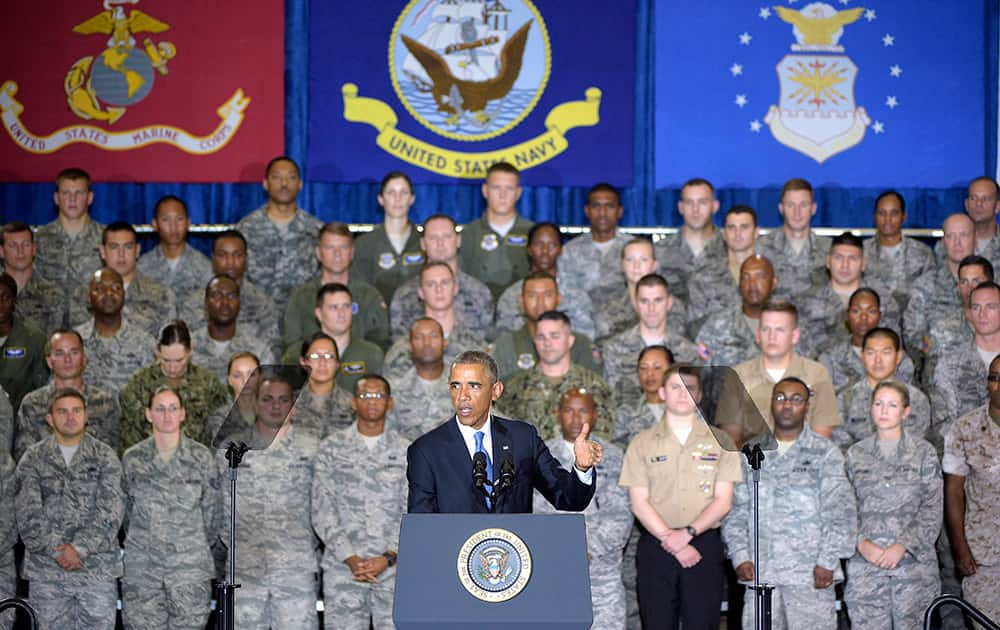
406 351 601 514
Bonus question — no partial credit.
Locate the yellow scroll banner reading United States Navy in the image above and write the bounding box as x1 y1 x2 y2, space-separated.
341 83 601 179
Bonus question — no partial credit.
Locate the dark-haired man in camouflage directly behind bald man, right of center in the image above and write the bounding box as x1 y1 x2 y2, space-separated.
687 206 760 334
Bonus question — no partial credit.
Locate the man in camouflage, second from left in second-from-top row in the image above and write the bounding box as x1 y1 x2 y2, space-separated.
69 221 177 335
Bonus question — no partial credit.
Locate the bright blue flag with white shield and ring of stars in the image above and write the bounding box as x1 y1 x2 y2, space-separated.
656 0 986 188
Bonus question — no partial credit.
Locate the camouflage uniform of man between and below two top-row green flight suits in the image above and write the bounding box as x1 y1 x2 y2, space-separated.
389 269 493 341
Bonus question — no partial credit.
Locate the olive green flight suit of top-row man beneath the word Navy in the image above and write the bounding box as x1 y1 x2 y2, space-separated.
458 212 535 300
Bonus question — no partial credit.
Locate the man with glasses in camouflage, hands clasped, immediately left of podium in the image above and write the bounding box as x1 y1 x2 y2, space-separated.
312 375 410 630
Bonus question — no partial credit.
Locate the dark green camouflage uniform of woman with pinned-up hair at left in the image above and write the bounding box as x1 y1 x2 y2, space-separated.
118 363 229 452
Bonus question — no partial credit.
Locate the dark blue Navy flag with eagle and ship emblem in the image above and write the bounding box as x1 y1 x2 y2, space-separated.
307 0 636 186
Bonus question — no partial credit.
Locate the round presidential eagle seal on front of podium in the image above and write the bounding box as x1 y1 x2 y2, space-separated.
458 527 531 602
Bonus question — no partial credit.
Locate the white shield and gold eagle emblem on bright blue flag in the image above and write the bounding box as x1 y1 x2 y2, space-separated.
764 2 871 164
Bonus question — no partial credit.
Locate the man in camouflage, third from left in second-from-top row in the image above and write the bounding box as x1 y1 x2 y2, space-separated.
178 230 281 348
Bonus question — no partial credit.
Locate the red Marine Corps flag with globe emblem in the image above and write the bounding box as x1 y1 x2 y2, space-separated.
0 0 284 182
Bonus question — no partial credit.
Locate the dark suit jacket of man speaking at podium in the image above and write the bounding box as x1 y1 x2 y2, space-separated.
406 416 597 514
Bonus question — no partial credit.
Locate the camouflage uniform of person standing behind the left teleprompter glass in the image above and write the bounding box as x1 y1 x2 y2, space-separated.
220 420 319 630
